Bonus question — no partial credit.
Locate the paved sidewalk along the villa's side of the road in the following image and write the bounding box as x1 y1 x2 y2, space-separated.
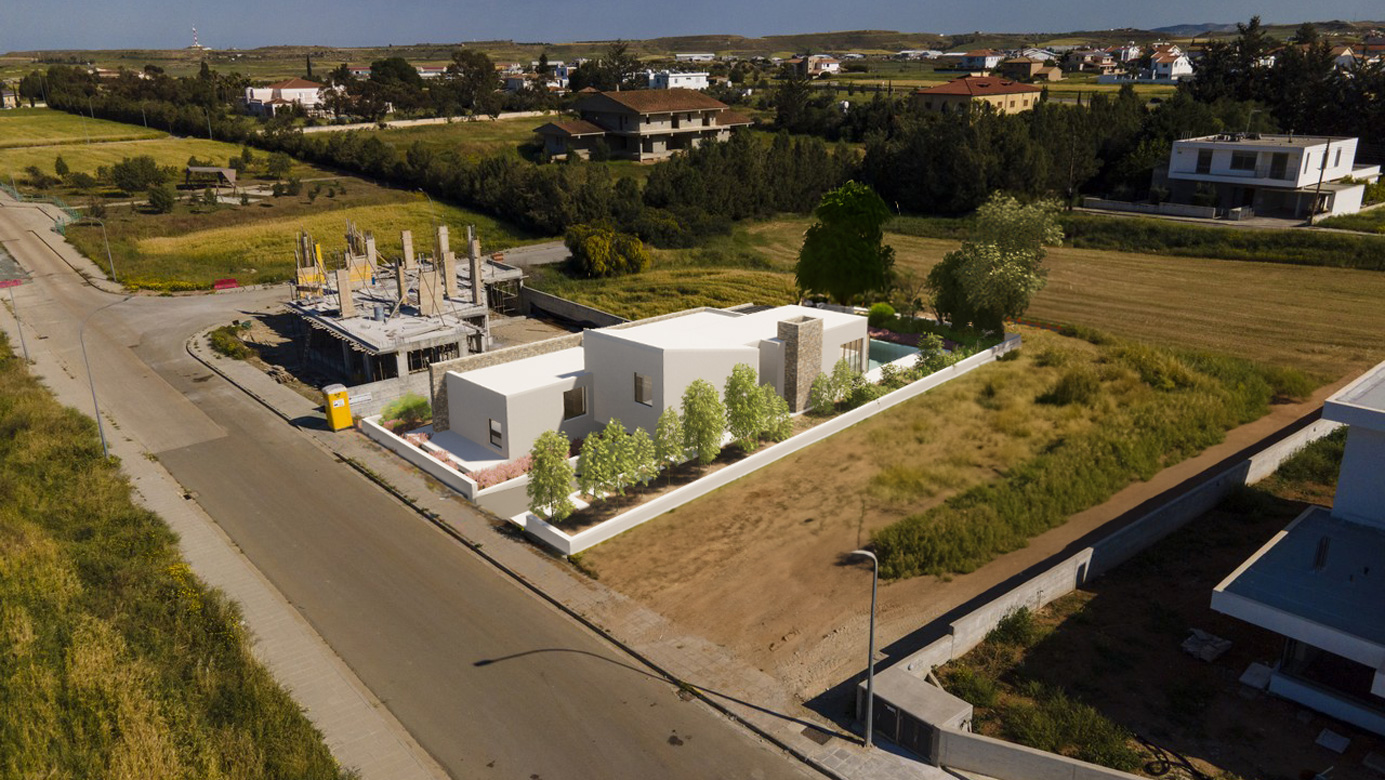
190 337 956 780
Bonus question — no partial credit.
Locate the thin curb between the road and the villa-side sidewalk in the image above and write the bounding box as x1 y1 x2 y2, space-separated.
184 328 848 780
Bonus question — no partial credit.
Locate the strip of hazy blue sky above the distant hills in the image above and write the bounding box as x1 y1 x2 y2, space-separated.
0 0 1385 51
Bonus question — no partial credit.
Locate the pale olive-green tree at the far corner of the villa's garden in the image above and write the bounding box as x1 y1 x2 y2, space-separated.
928 194 1062 333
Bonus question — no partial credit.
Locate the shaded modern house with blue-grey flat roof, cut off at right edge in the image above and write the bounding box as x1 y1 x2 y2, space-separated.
1212 363 1385 736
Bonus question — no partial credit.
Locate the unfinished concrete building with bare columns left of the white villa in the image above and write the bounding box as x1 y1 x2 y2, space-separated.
287 223 524 414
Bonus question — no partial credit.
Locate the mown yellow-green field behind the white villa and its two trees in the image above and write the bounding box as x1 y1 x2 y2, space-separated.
533 218 1385 378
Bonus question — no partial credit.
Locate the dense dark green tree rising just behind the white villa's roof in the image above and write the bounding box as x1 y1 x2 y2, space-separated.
794 181 895 303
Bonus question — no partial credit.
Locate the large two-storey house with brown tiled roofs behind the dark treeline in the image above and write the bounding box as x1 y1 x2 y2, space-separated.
535 89 751 161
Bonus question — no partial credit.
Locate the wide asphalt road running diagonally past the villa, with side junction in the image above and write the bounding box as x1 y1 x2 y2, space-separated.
0 208 816 779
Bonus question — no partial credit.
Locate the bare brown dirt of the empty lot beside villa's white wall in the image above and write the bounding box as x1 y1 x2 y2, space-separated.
573 331 1327 701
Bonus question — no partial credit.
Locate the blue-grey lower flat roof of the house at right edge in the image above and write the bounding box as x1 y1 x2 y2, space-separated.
1216 507 1385 647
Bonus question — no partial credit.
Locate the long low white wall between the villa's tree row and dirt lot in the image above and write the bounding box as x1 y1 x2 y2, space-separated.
525 334 1021 556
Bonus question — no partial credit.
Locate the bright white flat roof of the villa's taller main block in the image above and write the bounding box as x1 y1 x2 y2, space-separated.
601 305 866 349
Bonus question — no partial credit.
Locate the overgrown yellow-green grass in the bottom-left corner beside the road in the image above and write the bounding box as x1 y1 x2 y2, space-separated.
0 337 345 780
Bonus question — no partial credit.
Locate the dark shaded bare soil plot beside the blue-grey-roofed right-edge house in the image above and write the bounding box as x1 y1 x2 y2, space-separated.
943 482 1385 780
